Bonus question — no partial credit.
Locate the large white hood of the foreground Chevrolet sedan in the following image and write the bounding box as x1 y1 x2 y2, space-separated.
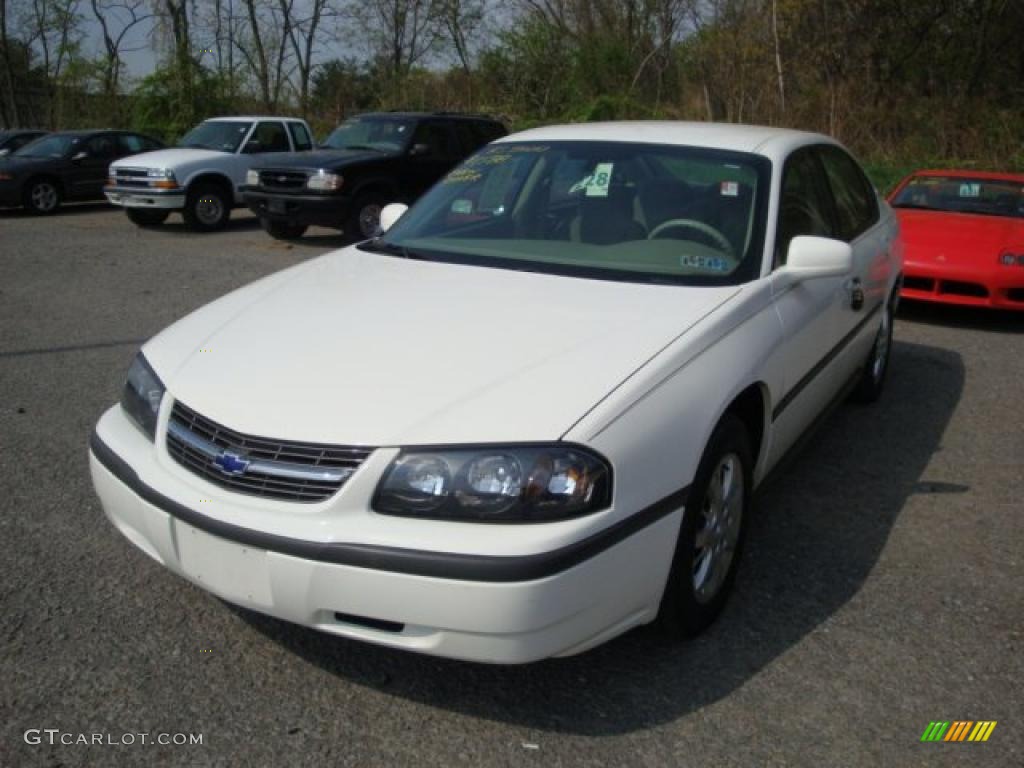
143 247 739 445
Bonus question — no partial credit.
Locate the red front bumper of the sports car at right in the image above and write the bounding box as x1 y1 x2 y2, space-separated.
900 262 1024 310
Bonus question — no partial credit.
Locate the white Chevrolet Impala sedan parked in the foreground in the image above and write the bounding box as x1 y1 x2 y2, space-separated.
90 123 902 663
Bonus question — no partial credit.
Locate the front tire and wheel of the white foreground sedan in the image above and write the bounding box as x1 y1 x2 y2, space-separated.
657 414 754 640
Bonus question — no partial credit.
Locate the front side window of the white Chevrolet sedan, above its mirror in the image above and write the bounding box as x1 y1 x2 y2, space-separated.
774 150 836 266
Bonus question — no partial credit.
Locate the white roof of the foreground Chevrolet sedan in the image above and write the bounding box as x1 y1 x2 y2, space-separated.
495 120 839 157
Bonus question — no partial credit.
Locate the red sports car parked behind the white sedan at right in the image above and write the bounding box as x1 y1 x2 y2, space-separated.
889 171 1024 310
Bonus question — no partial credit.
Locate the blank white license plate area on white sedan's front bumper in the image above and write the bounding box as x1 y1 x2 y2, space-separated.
175 521 272 605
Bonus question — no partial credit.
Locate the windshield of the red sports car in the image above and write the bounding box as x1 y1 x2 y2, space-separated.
892 176 1024 218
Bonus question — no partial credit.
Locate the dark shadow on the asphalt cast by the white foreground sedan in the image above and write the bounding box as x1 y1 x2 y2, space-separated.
236 342 965 735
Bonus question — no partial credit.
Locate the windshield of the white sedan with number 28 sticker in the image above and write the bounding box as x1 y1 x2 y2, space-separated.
364 141 770 285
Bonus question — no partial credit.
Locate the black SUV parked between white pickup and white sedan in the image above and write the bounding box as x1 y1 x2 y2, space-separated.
242 112 508 240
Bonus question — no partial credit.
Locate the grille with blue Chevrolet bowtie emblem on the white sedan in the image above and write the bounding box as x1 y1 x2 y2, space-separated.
167 401 373 502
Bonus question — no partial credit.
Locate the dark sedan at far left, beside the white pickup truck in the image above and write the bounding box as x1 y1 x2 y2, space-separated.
0 131 163 214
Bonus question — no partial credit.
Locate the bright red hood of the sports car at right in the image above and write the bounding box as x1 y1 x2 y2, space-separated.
896 208 1024 267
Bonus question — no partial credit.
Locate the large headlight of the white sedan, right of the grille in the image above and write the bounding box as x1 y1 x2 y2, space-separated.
373 442 611 522
